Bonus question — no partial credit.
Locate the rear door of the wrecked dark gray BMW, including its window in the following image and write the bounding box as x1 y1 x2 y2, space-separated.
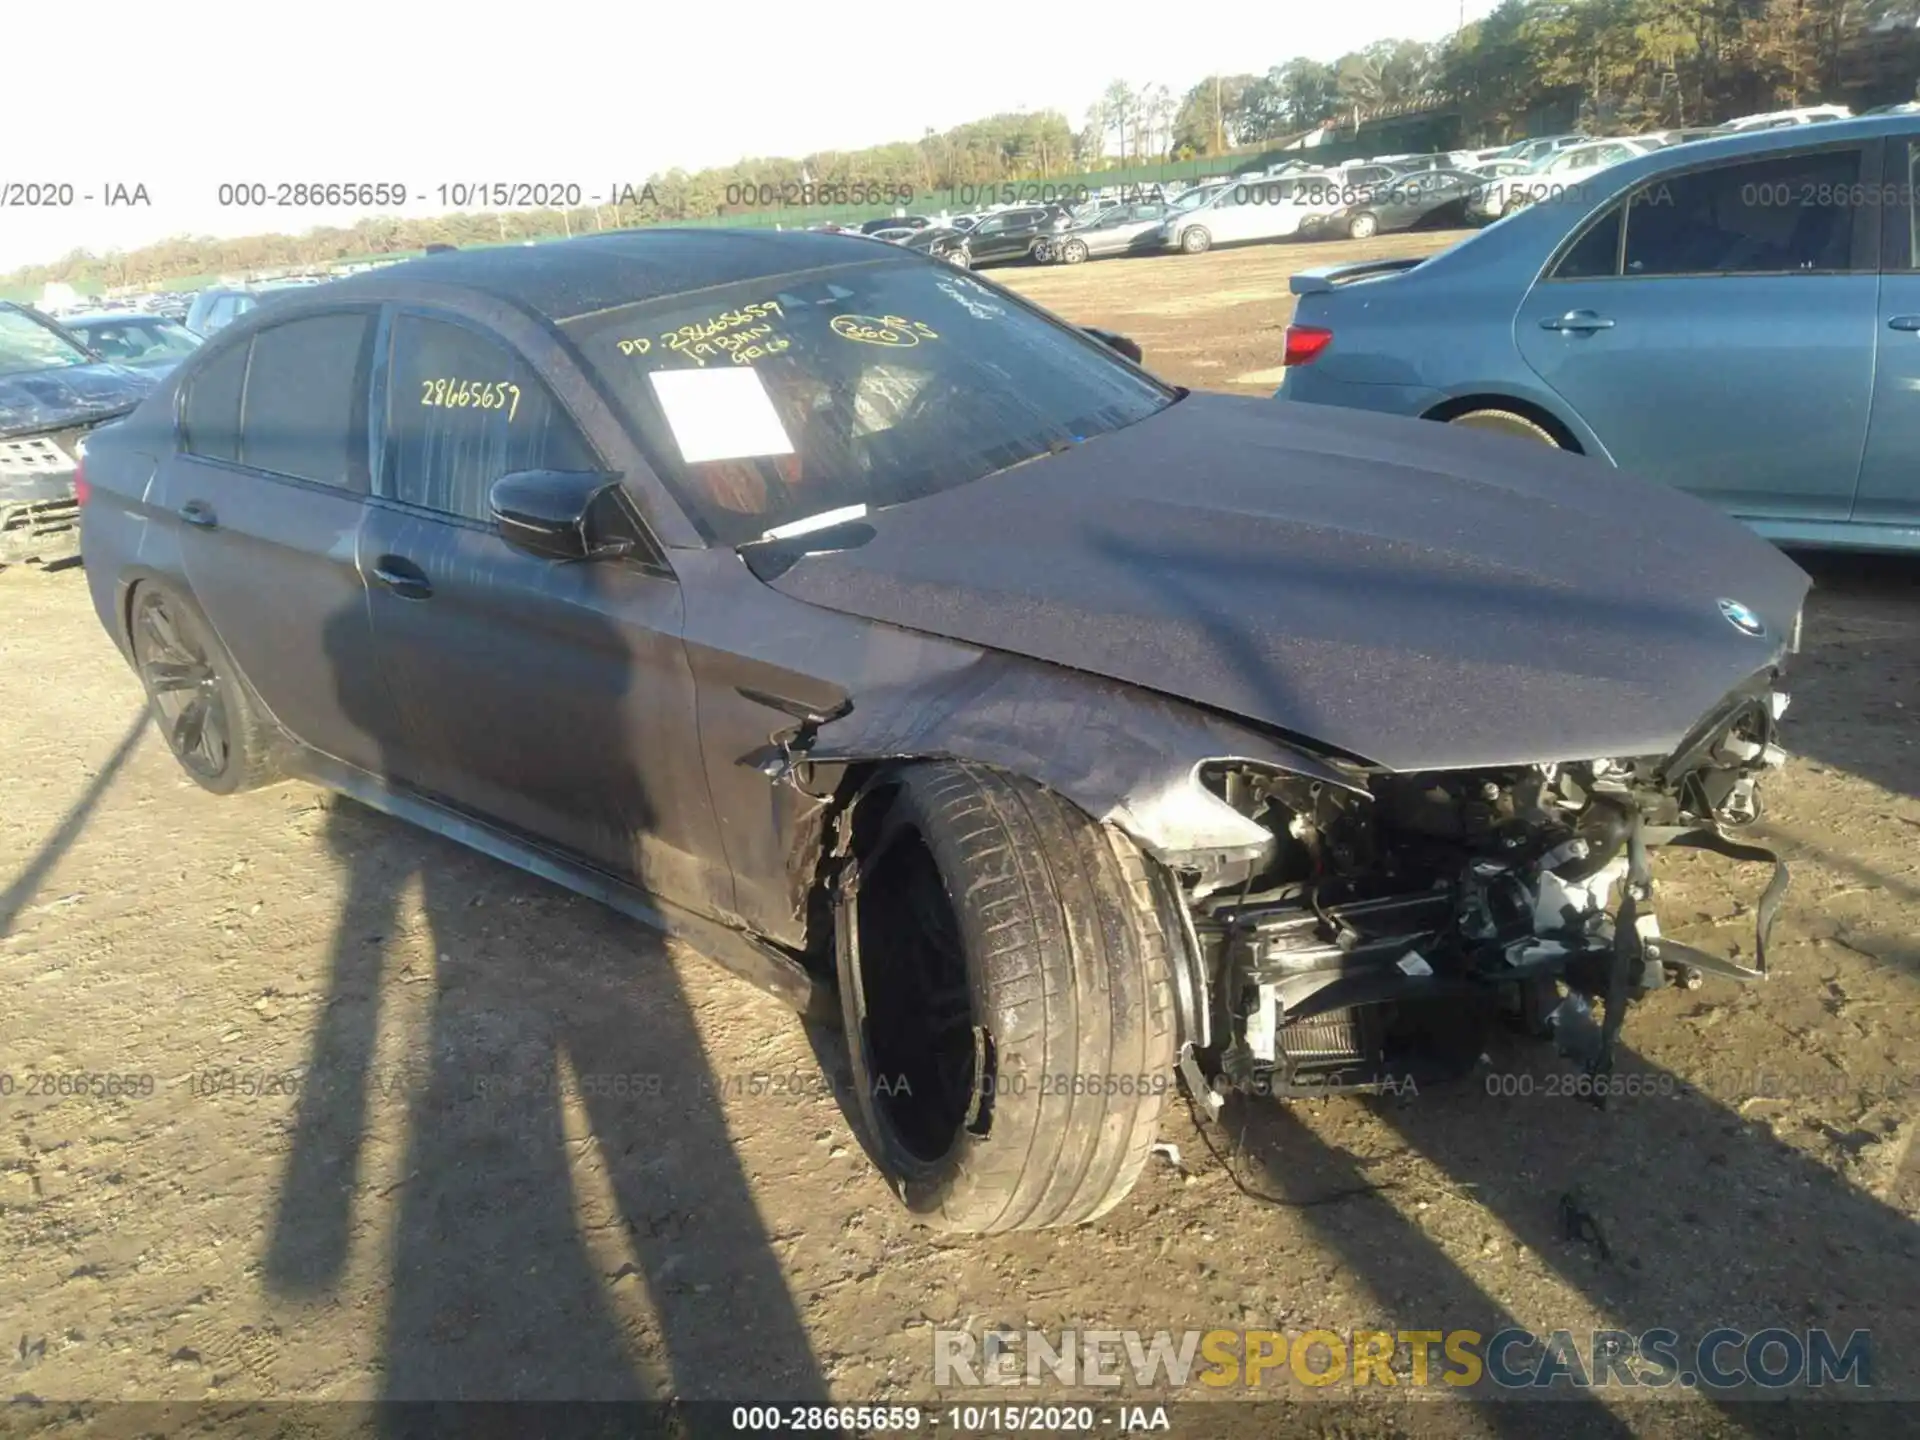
157 309 394 768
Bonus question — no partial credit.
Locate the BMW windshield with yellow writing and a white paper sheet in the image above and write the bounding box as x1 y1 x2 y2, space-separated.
563 259 1175 545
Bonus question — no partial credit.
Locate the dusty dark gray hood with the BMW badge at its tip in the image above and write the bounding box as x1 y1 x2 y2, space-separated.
770 394 1809 770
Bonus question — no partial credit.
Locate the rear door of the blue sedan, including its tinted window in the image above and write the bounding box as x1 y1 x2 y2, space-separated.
1515 142 1880 520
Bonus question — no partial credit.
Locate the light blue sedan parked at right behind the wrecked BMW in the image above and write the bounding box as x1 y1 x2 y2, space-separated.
1279 115 1920 551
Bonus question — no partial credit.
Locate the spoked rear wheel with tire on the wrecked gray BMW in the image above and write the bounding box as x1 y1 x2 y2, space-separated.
127 580 282 795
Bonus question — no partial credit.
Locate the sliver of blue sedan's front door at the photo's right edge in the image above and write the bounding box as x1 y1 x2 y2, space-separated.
1853 136 1920 526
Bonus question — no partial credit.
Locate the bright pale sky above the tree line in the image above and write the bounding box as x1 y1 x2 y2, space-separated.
0 0 1492 275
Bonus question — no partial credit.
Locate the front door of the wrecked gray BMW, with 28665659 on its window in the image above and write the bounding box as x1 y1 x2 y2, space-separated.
367 309 732 904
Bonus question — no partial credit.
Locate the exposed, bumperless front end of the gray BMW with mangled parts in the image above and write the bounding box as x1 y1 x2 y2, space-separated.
1171 678 1788 1106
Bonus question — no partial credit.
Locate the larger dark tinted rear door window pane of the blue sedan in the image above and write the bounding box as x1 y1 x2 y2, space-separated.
1626 150 1862 276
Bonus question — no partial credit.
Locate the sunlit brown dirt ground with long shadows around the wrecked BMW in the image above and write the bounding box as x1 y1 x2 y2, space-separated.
0 236 1920 1436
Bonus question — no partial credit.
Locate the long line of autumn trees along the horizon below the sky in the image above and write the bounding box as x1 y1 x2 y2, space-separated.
0 0 1920 290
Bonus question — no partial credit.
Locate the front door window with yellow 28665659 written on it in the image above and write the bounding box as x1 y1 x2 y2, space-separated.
386 315 599 520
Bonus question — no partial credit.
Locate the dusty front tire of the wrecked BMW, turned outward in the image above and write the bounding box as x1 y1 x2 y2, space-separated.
835 762 1185 1235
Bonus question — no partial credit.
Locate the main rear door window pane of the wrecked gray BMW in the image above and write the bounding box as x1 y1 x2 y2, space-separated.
240 315 372 490
